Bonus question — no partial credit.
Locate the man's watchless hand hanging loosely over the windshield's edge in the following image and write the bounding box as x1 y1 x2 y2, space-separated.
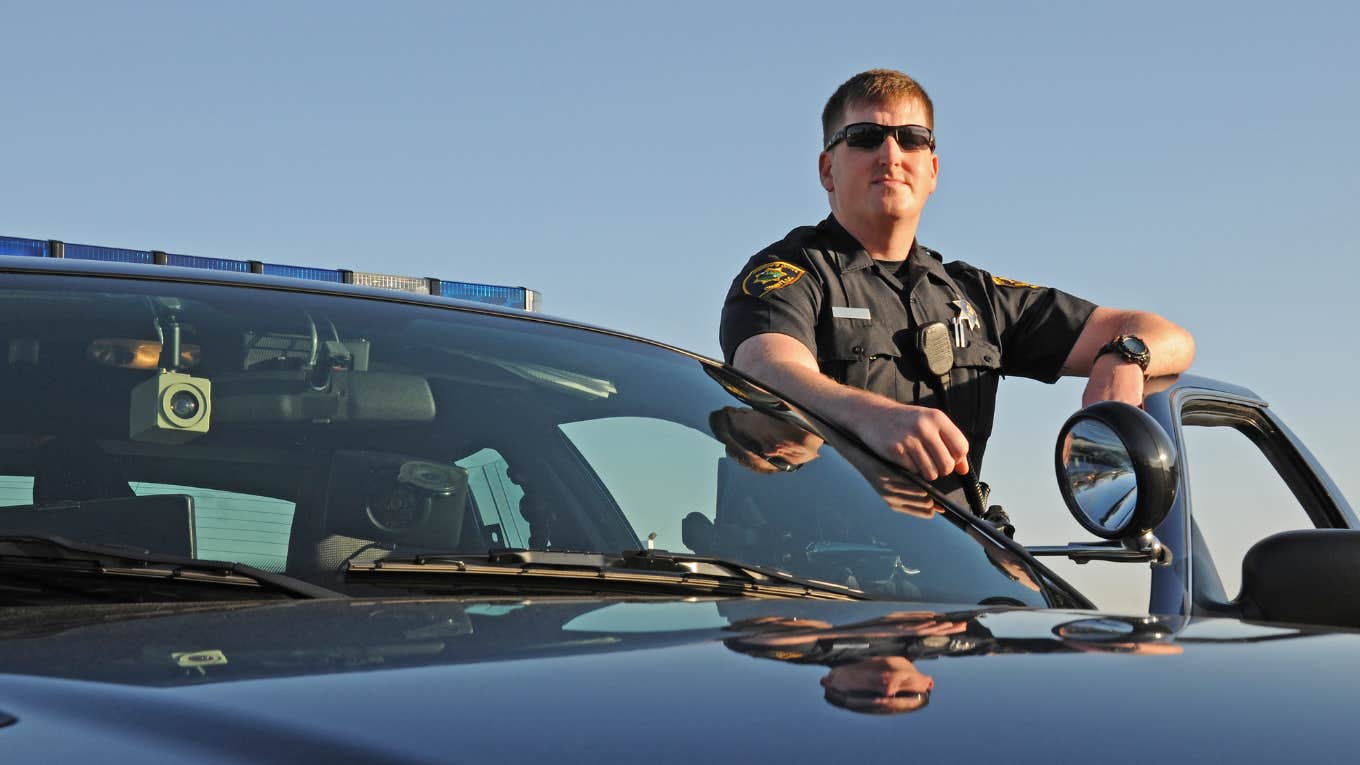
855 404 968 481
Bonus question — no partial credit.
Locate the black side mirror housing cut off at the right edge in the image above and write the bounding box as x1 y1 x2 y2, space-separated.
1236 528 1360 628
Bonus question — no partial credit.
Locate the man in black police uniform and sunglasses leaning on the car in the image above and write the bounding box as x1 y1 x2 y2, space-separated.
721 69 1194 489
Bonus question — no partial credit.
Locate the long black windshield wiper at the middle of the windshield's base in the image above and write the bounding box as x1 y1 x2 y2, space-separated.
345 550 870 600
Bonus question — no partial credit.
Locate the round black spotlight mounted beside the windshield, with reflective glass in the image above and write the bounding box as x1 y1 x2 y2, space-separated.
1055 402 1180 539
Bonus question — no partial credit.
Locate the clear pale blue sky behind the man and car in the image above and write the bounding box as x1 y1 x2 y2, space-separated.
0 0 1360 602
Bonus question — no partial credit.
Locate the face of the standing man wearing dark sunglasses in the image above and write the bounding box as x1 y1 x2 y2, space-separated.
817 101 940 229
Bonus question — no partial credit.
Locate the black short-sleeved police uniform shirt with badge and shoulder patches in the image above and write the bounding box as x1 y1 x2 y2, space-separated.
721 210 1096 470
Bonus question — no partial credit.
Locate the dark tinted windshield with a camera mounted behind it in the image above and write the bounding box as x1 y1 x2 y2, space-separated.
0 275 1046 606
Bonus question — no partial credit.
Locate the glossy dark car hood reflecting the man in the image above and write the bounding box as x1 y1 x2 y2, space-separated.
0 600 1360 762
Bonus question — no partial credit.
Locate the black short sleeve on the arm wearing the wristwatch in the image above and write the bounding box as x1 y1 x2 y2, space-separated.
982 272 1096 383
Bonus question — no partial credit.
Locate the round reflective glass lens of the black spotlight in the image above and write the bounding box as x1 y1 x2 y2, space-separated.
1062 419 1138 532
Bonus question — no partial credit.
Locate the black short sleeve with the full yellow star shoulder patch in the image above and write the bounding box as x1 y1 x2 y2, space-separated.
718 250 821 363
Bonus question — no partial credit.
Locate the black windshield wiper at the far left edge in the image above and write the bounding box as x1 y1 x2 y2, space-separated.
0 534 347 598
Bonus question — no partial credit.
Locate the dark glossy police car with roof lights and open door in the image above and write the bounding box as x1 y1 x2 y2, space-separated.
0 240 1360 762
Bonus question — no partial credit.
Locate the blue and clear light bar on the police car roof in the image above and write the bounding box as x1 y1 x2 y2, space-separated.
0 237 543 310
